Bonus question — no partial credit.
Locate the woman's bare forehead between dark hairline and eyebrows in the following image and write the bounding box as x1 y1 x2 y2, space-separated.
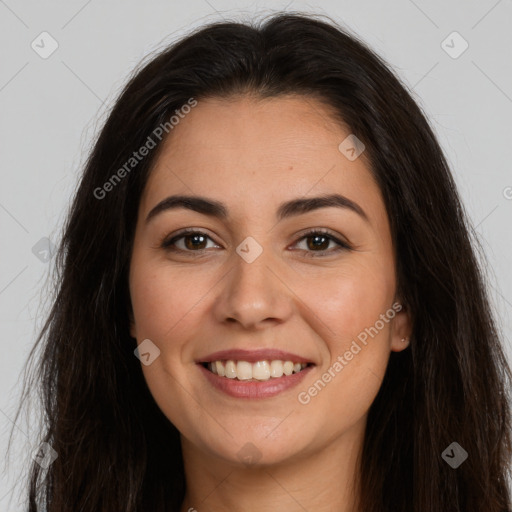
141 96 384 226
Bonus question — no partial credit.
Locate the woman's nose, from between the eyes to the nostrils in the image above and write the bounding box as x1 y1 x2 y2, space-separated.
214 238 293 330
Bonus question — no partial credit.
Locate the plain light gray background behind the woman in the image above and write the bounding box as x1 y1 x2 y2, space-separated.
0 0 512 511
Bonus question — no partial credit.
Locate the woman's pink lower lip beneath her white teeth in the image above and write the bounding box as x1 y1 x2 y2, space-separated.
198 364 313 398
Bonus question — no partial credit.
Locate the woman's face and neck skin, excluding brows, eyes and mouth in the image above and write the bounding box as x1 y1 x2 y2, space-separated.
129 96 411 512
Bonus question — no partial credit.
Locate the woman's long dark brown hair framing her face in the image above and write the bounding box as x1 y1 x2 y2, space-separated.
10 13 512 512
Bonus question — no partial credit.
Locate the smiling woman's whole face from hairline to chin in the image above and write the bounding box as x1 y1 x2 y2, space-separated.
130 96 410 464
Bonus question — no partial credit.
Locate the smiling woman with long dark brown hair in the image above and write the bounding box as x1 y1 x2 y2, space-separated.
12 9 512 512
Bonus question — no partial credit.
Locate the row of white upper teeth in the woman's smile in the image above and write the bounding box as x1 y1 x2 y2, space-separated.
208 360 307 380
